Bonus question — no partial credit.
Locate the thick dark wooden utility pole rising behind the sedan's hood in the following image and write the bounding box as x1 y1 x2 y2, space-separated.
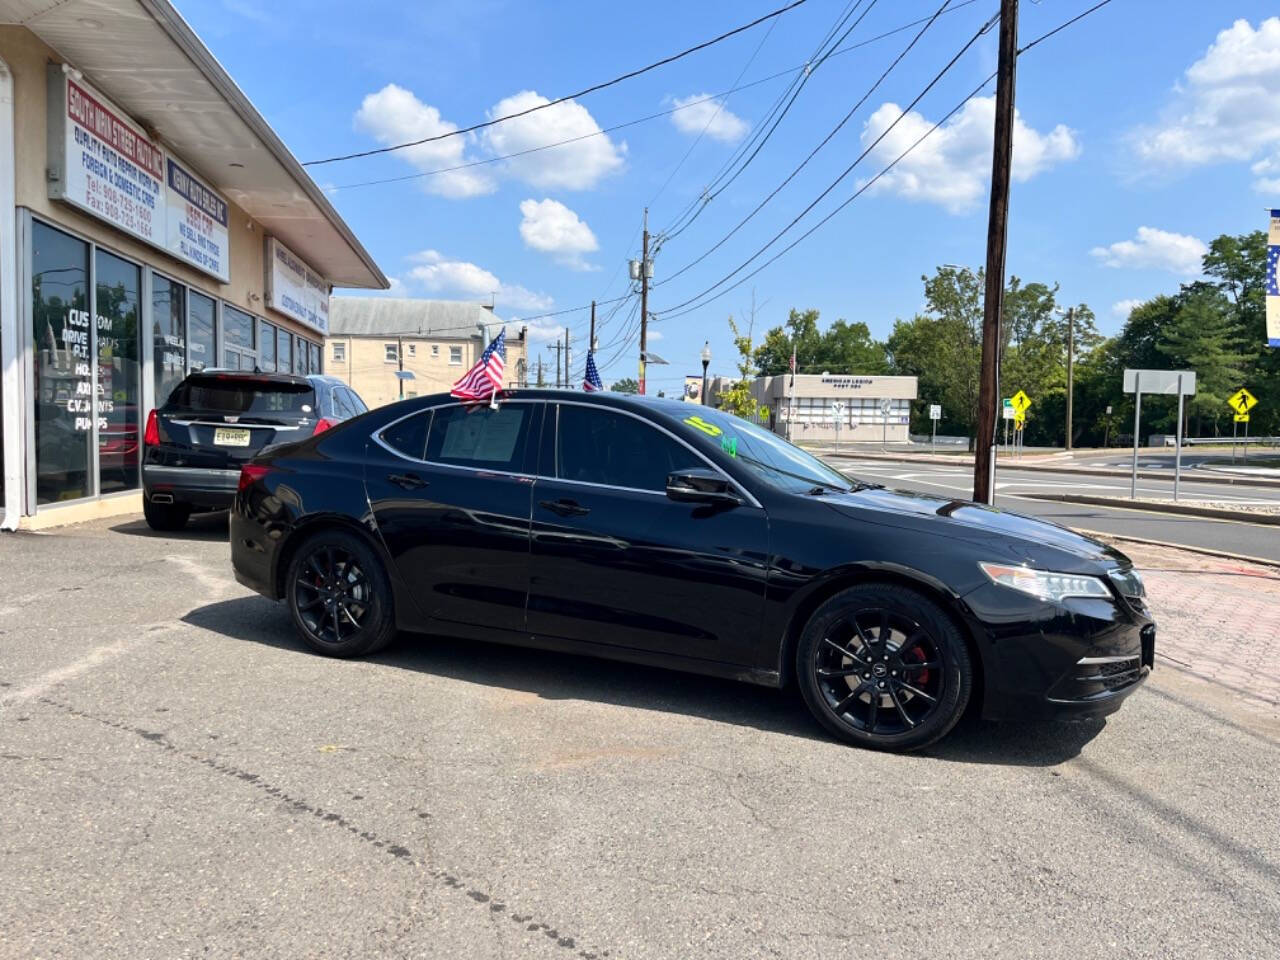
973 0 1018 512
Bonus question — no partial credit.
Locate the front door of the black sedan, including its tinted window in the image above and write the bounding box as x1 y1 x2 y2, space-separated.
529 402 769 664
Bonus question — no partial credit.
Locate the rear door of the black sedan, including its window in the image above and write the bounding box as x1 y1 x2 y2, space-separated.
365 401 543 632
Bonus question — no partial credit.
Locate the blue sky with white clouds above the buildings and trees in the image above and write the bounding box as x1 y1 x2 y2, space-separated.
178 0 1280 392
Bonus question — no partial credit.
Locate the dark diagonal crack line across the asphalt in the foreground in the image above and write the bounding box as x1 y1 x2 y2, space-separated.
37 696 617 960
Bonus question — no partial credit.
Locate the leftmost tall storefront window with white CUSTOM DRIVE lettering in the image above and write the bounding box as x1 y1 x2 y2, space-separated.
31 223 93 503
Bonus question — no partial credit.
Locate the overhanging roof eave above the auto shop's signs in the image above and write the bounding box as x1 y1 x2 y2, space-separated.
0 0 389 289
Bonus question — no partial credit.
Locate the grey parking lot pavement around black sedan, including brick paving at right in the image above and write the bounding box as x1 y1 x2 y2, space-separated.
0 518 1280 959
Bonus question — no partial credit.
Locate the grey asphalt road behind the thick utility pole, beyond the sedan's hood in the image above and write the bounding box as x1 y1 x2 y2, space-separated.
824 456 1280 562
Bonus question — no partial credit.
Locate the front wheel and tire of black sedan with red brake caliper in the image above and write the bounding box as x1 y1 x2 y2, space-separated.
796 584 973 751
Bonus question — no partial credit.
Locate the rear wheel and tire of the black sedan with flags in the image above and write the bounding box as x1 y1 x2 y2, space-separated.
284 530 396 658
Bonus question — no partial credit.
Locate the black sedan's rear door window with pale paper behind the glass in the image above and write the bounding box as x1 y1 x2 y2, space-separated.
425 403 534 472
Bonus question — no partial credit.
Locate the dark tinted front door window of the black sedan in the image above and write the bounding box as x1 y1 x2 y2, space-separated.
556 403 707 493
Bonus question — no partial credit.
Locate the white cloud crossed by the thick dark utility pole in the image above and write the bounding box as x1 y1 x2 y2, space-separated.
861 97 1080 214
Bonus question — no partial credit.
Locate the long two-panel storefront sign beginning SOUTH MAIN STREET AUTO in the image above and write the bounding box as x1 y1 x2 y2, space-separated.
47 65 230 283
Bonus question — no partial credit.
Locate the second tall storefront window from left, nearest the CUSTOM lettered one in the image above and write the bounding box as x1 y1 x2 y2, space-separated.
93 250 142 493
